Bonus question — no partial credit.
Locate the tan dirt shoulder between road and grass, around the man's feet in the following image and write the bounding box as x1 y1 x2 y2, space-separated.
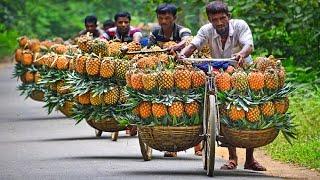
216 147 320 179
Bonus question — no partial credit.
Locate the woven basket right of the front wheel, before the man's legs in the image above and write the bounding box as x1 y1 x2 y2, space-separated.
221 125 279 148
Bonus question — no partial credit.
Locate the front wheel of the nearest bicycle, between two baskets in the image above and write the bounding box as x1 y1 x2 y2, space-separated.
206 95 217 176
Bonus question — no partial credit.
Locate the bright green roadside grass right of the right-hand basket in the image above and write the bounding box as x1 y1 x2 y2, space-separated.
265 67 320 171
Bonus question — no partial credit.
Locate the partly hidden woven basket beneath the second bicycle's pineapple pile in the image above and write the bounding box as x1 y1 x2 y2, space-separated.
87 118 126 132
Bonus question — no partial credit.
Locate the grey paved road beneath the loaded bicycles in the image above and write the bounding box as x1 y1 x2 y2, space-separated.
0 66 276 180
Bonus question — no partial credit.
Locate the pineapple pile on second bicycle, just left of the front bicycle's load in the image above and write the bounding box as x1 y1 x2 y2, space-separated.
67 35 141 127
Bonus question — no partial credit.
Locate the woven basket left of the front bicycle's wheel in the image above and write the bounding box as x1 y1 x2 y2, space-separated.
138 126 203 152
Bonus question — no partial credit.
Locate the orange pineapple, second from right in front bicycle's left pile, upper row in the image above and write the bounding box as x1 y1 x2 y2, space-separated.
174 67 191 90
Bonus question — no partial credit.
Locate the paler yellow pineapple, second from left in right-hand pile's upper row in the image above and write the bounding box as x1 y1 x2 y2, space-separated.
231 70 248 91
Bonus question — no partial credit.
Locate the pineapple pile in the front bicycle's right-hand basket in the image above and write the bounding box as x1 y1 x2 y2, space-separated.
215 55 293 140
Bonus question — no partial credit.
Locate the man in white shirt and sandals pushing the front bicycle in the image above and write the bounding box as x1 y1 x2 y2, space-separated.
179 1 266 171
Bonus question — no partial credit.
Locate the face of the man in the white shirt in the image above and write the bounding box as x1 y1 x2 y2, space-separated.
208 13 229 35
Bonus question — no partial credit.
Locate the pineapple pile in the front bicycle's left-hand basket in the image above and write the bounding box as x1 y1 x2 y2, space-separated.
126 45 205 126
